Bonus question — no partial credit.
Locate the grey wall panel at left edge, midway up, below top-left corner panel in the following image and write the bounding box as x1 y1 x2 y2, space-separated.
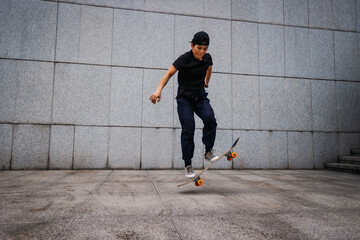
0 60 54 123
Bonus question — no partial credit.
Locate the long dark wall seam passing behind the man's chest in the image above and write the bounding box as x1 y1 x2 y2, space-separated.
0 57 360 83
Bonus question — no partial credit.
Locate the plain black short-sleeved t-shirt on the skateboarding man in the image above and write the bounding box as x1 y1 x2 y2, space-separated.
173 50 213 100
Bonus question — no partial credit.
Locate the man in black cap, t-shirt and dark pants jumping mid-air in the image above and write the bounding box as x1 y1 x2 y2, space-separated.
150 32 218 178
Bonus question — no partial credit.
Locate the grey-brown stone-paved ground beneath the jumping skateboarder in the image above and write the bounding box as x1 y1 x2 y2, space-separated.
0 170 360 239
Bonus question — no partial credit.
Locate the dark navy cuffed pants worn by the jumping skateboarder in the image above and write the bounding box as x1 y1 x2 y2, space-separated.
177 95 217 166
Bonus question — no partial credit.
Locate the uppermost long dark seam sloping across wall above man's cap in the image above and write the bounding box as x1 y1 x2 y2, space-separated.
57 1 359 33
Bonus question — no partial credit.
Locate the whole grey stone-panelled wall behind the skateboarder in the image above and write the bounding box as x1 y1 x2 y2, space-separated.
0 0 360 169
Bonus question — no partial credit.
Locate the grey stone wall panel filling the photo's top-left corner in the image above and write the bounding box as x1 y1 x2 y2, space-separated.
0 0 57 61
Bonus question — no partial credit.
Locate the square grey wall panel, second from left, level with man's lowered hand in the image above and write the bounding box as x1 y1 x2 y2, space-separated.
52 64 111 125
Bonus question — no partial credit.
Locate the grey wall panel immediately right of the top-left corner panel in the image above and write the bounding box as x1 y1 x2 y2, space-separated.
56 3 113 64
